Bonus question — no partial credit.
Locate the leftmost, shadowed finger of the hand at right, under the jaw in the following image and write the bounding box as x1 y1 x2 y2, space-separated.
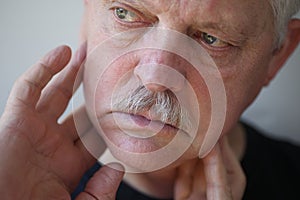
174 160 197 200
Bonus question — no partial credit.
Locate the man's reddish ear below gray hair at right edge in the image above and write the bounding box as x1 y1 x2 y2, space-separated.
265 19 300 85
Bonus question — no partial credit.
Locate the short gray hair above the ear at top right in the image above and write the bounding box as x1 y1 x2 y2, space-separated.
269 0 300 46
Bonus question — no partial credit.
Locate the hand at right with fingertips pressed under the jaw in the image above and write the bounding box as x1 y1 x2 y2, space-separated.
174 137 246 200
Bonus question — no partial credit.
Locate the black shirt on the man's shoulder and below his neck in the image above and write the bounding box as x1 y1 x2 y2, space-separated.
72 124 300 200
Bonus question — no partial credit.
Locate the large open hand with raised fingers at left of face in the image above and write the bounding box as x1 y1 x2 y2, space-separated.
0 45 123 200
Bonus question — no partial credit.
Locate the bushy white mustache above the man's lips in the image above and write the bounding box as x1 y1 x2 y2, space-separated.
113 86 192 131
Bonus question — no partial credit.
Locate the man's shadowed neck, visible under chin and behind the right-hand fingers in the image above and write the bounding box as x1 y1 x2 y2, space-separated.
124 124 246 199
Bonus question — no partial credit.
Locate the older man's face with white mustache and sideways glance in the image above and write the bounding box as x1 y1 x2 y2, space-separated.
83 0 274 170
